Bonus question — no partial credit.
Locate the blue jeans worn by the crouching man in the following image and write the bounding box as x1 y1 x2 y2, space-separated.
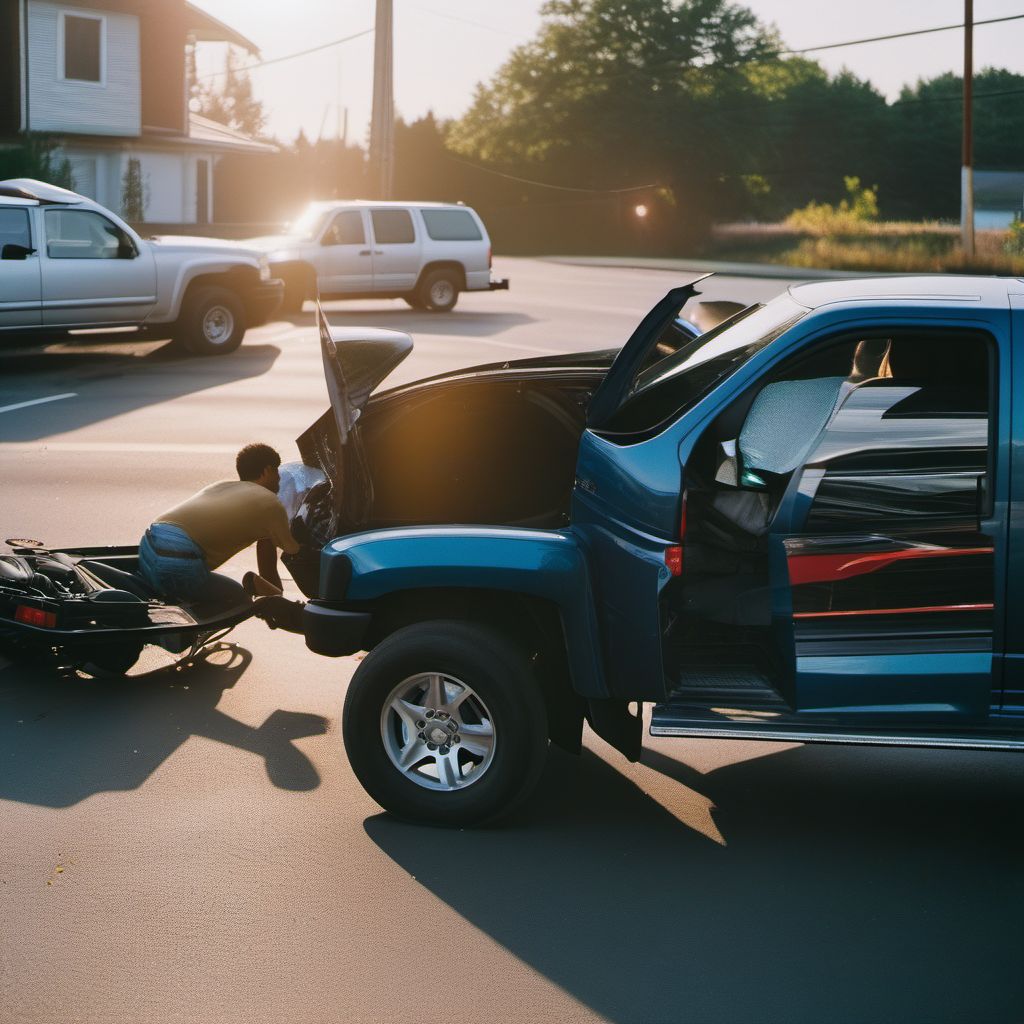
138 522 250 606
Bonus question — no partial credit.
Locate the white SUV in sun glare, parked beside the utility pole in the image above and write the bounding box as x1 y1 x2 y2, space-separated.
258 200 509 312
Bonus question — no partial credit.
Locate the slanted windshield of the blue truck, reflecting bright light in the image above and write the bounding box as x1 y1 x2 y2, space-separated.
601 294 807 434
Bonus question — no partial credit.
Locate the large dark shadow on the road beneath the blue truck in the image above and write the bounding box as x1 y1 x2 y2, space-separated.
365 748 1024 1024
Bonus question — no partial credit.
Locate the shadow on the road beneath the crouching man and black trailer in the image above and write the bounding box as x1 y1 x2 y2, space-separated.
0 644 327 807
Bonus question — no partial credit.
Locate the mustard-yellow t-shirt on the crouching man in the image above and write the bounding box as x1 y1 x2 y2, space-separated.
155 480 299 569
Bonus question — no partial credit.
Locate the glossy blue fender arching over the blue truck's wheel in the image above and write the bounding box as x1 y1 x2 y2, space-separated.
321 526 608 698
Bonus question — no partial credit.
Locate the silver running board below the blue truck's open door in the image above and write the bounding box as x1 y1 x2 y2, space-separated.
650 705 1024 751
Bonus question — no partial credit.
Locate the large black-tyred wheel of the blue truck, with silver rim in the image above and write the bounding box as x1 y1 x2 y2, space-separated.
342 621 548 826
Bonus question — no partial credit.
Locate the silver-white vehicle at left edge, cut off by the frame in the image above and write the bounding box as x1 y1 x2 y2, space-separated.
0 178 284 355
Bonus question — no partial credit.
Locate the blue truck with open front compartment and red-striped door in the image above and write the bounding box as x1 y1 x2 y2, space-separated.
292 276 1024 825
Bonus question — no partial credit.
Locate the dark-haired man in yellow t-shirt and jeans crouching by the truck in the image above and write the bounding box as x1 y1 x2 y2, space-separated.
138 444 299 607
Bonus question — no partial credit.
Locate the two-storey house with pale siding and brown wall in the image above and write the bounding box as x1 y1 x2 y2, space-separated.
0 0 275 224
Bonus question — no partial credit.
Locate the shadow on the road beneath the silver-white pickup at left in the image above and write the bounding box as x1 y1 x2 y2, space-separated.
0 337 281 442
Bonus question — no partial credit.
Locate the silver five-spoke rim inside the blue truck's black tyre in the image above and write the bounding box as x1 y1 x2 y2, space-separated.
380 672 496 793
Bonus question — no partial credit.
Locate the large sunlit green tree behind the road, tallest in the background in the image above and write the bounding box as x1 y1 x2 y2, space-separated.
449 0 778 237
